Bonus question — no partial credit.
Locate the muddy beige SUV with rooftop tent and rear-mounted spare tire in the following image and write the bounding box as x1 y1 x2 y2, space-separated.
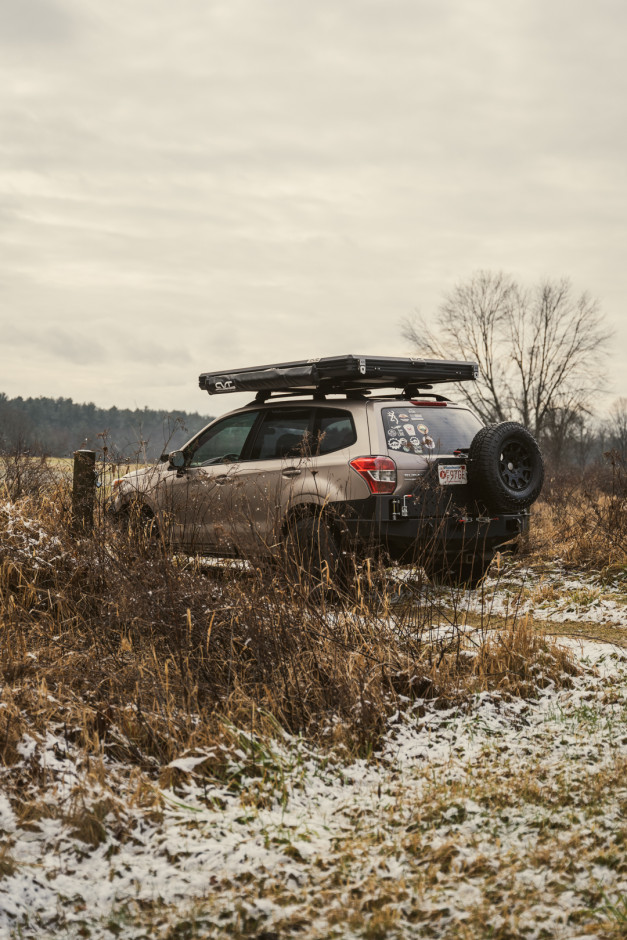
112 356 543 582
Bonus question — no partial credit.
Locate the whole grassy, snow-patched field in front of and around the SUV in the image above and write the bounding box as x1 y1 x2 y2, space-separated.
0 464 627 940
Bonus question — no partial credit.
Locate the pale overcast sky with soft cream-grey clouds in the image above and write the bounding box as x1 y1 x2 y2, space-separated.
0 0 627 413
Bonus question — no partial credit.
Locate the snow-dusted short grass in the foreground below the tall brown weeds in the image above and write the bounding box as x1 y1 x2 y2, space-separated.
0 640 627 940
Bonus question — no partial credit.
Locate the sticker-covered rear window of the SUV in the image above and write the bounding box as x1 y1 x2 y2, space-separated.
381 404 483 457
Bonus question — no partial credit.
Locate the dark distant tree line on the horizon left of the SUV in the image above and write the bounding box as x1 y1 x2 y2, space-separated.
0 392 211 460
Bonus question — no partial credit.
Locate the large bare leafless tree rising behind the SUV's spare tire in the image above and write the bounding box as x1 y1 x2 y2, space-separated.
403 271 610 445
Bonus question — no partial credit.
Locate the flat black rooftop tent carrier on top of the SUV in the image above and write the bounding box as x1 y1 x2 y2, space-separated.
198 356 478 400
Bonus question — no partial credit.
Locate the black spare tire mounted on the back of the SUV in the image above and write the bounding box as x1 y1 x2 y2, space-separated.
468 421 544 512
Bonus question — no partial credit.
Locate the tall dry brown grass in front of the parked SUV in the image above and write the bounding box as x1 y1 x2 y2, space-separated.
0 456 572 773
